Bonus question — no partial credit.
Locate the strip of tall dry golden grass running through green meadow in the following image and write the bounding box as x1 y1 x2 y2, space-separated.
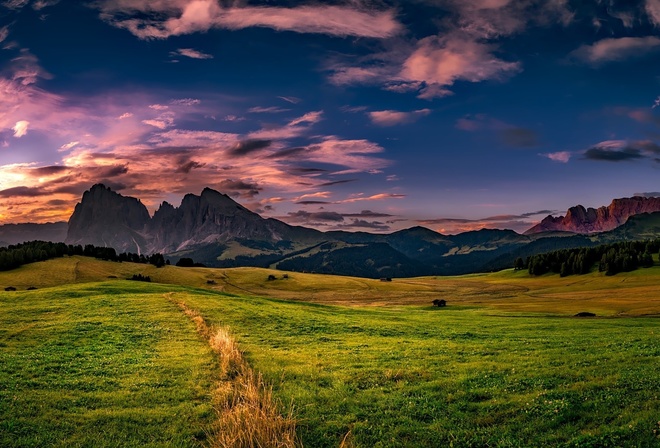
174 295 302 448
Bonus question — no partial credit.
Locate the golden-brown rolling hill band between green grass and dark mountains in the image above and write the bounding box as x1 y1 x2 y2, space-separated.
0 256 660 316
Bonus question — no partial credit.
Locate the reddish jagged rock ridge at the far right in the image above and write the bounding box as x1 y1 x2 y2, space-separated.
525 196 660 235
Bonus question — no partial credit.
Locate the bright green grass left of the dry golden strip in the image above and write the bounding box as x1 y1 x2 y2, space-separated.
0 282 216 447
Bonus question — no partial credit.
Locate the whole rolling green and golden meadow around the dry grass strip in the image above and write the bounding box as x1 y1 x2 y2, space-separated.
0 257 660 447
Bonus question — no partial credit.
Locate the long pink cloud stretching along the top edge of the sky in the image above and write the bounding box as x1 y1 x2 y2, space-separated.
97 0 401 39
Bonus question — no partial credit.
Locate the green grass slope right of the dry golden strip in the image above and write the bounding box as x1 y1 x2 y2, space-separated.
177 288 660 447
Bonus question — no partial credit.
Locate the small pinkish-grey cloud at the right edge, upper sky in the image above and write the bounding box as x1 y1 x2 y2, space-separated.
569 36 660 65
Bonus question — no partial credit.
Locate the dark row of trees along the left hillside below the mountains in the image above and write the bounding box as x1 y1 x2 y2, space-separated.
0 241 169 271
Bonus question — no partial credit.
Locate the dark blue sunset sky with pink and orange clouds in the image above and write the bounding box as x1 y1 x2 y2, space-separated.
0 0 660 234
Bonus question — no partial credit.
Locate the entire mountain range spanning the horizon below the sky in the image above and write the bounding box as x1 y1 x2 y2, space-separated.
0 184 660 278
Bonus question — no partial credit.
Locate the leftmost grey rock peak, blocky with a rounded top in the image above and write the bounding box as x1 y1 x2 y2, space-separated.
66 184 151 253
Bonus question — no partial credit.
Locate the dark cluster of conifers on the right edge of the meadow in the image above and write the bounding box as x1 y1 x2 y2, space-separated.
514 239 660 277
